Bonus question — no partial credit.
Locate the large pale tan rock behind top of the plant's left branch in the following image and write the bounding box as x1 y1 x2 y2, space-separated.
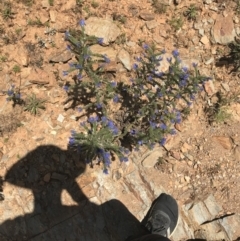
85 17 121 45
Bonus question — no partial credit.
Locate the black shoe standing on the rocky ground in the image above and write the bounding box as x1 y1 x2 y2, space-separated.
142 193 178 238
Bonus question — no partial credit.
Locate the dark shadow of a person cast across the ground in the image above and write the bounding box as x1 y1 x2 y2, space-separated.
0 145 146 241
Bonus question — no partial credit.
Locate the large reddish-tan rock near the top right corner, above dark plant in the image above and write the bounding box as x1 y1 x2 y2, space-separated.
212 14 236 44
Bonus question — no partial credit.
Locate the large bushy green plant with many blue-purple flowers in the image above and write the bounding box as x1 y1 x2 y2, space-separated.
63 20 209 173
